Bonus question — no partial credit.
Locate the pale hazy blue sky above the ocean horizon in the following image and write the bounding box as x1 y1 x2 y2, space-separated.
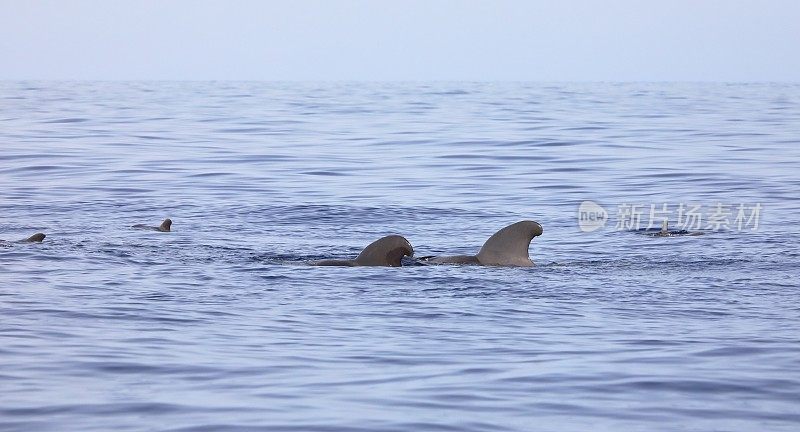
0 0 800 81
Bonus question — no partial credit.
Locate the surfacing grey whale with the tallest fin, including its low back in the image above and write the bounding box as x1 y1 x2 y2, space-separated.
423 220 542 267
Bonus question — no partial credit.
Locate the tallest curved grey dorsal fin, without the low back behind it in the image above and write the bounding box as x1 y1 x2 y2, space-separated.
477 220 542 267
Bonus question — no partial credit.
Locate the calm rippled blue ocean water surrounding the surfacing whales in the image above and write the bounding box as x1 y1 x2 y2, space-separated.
0 82 800 432
